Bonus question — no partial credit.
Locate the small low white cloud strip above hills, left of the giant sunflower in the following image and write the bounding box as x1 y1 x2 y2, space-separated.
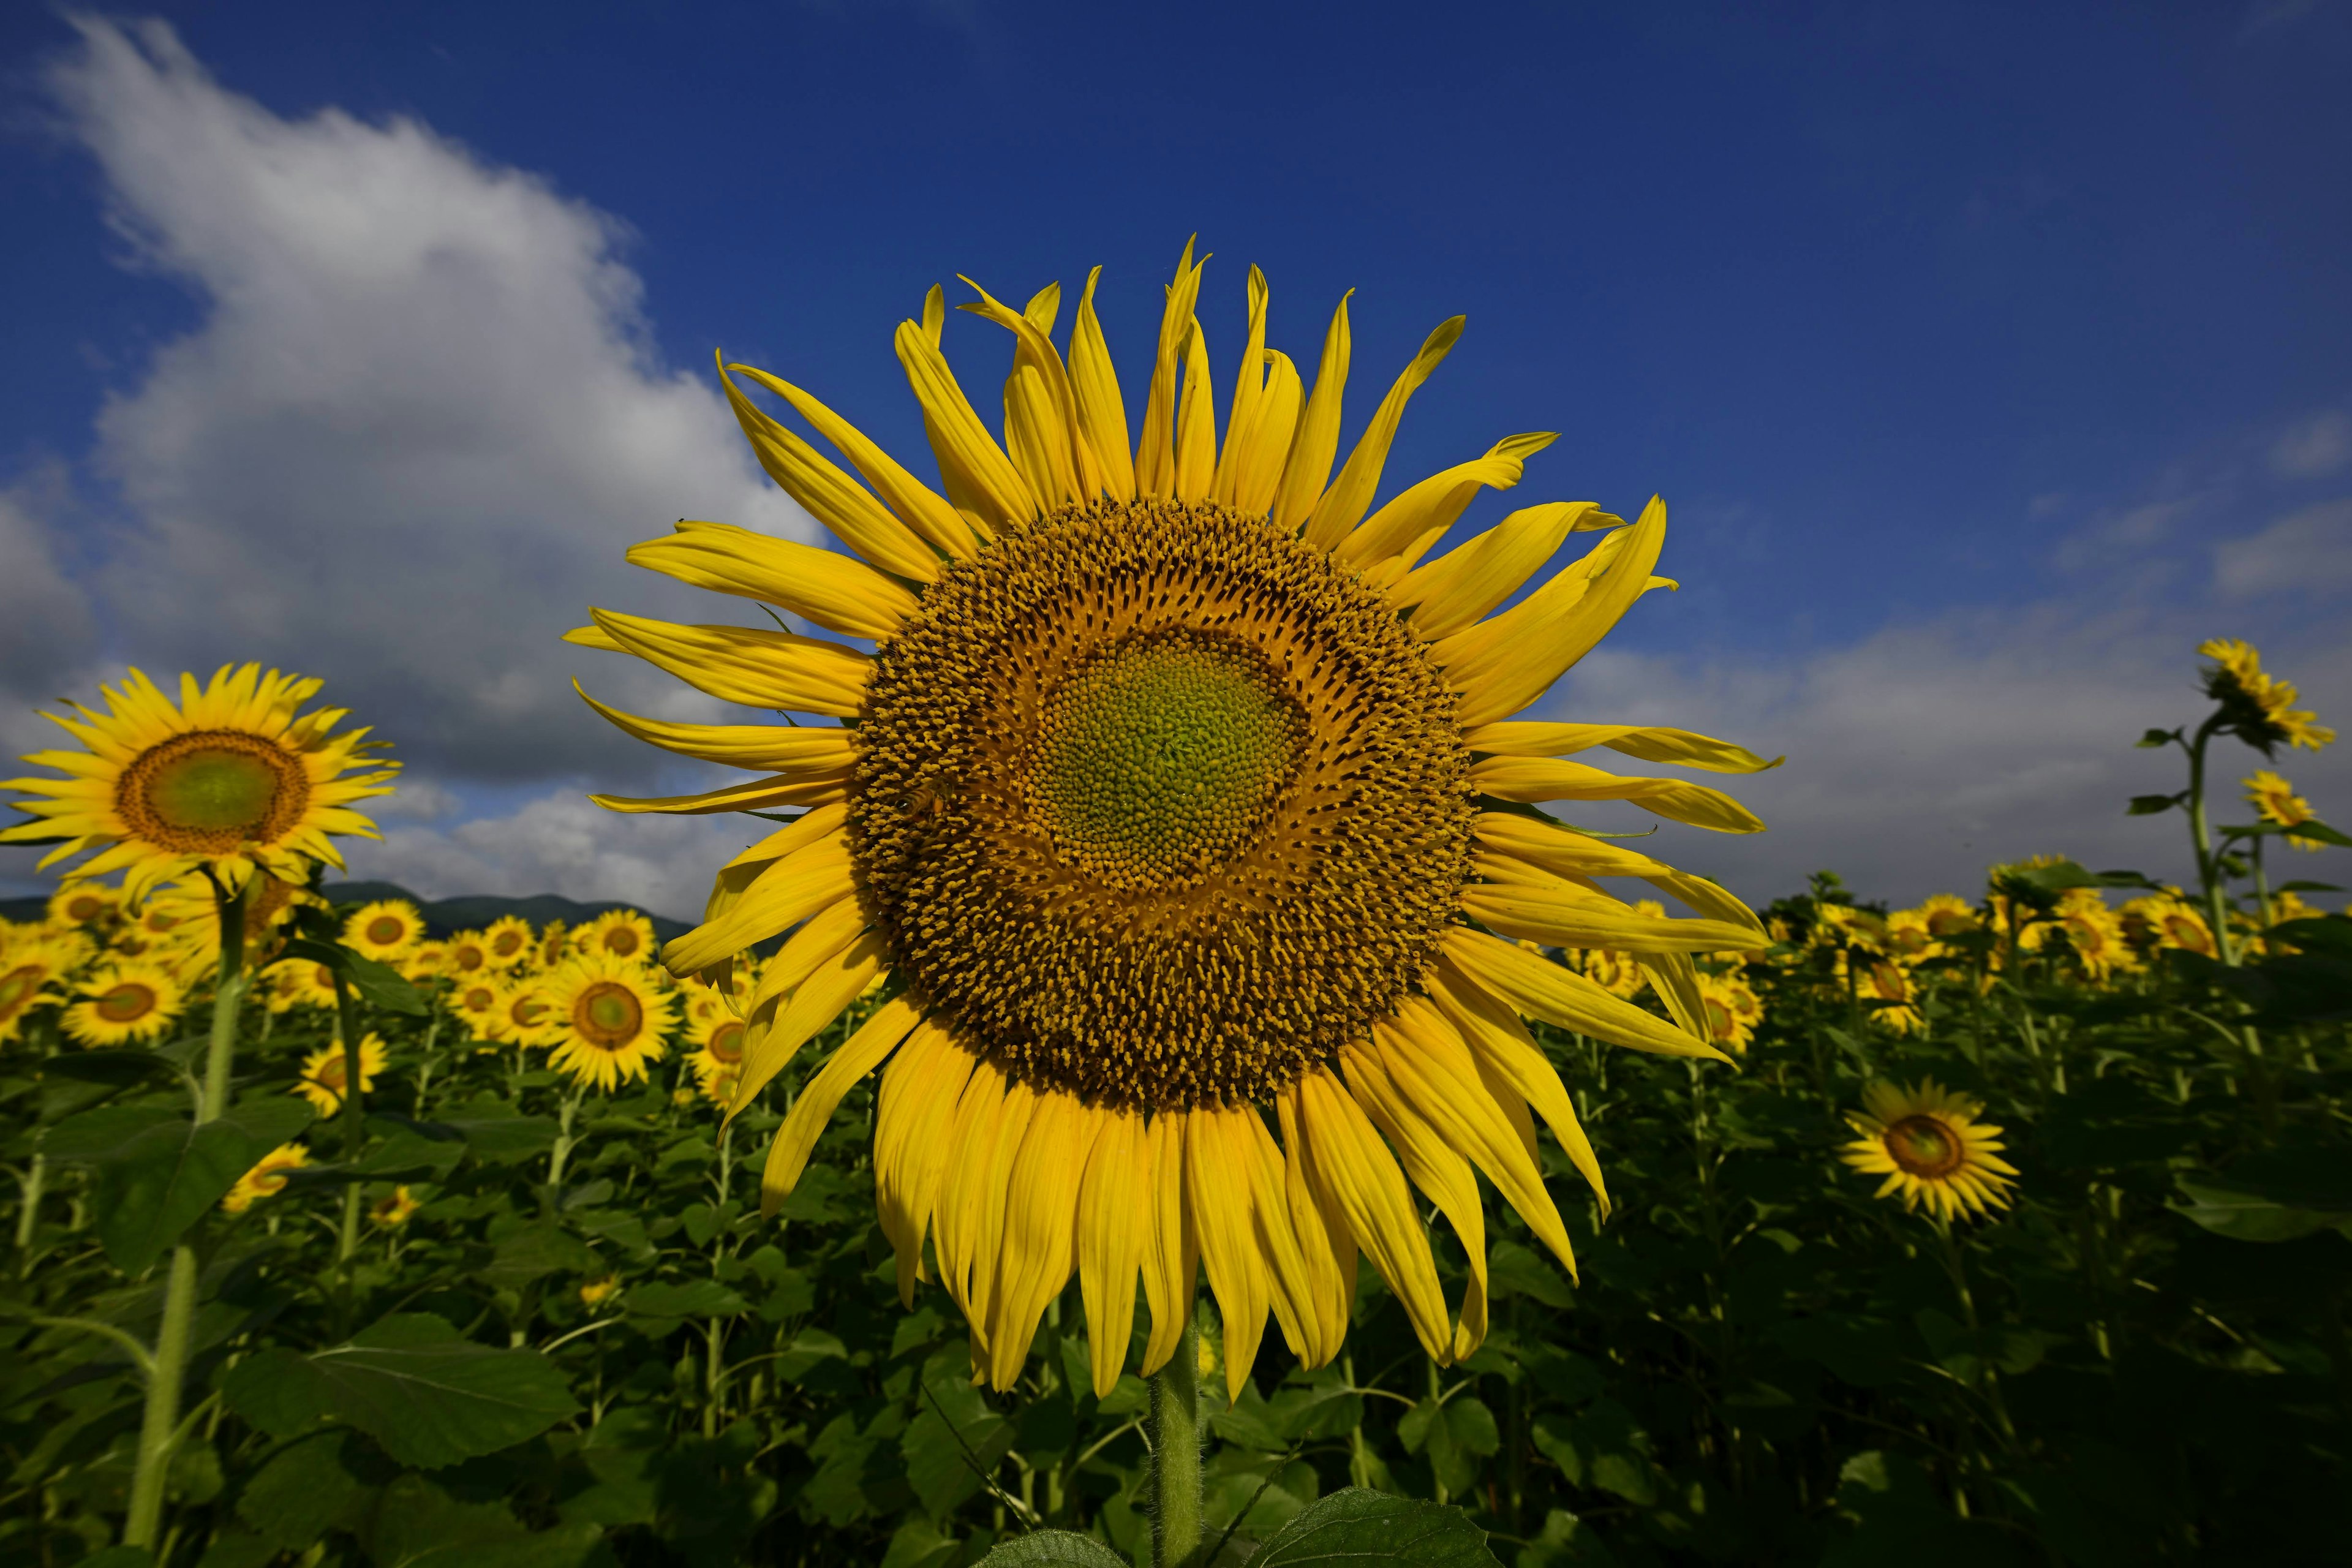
344 790 774 919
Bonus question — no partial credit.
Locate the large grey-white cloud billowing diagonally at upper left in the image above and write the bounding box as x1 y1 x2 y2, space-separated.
50 19 814 778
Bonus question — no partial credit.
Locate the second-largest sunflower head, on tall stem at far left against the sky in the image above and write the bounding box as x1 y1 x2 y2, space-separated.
0 665 398 903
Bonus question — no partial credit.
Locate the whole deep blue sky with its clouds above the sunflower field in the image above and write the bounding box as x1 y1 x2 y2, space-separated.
0 2 2352 912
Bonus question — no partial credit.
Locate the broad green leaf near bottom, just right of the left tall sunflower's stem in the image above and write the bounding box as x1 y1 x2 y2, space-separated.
221 1312 579 1469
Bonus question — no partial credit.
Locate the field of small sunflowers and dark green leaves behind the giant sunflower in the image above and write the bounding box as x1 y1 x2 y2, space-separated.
0 653 2352 1568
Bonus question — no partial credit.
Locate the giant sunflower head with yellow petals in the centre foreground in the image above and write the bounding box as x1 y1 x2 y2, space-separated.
571 247 1769 1389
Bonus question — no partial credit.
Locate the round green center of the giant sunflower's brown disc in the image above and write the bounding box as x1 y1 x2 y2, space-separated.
1030 632 1298 886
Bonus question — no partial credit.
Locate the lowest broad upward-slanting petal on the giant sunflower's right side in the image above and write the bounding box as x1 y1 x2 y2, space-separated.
1430 499 1665 729
